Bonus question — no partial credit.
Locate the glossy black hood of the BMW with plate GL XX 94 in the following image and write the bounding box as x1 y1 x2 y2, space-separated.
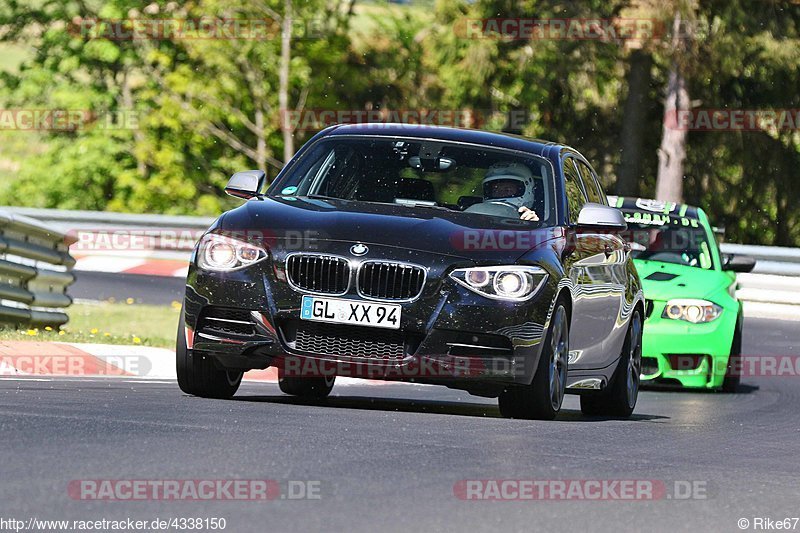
214 197 559 263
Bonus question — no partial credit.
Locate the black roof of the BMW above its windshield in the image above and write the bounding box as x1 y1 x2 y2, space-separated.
325 123 560 155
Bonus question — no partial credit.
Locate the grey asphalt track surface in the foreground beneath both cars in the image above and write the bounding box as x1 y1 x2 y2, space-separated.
0 319 800 532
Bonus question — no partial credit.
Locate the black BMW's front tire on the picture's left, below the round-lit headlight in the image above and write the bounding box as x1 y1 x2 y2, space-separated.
175 310 243 399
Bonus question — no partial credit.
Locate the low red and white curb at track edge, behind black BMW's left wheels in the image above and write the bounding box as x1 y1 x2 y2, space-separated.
0 341 386 385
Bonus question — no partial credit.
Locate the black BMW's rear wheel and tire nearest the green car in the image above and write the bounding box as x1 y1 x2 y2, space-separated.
581 309 643 418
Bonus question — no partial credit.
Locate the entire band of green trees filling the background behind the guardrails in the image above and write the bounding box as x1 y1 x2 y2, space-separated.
0 0 800 245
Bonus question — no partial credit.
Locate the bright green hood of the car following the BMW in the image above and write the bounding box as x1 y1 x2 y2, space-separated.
633 259 735 303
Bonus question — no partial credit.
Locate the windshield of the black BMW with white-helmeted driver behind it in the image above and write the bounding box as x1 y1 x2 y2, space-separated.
270 137 556 225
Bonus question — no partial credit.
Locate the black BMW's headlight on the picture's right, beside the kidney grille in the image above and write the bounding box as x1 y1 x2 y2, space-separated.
450 265 547 302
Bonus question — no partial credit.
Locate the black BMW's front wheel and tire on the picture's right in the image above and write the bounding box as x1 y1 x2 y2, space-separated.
498 301 569 420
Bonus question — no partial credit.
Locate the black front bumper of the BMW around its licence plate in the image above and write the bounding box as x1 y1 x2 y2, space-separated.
184 247 555 394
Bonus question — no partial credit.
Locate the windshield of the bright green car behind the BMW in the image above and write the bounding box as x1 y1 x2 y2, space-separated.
624 211 714 270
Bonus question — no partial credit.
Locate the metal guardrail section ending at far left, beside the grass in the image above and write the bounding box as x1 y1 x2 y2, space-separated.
0 209 75 326
